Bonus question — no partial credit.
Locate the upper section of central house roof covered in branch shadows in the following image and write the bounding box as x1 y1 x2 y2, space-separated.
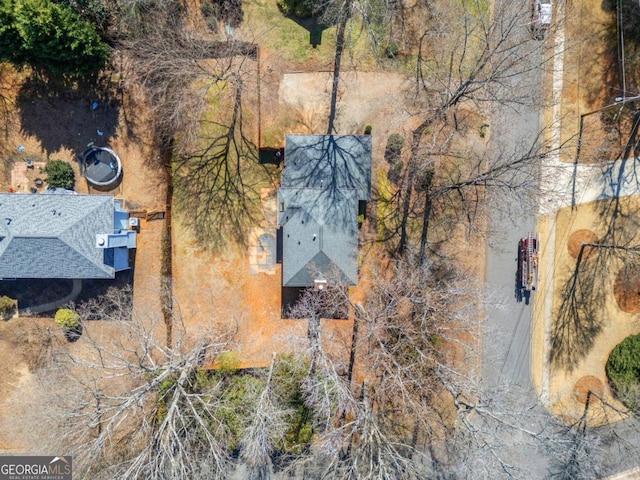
281 135 371 200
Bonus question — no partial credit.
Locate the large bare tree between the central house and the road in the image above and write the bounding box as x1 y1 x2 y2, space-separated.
390 0 549 257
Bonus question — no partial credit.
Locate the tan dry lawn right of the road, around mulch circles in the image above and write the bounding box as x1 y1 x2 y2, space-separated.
533 197 640 424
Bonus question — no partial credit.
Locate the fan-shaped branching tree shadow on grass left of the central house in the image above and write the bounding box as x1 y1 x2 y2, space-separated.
173 77 277 250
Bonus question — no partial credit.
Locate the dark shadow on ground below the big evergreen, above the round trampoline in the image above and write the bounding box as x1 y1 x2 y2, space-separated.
16 73 121 154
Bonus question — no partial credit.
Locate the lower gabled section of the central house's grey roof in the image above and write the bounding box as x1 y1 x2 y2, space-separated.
279 188 358 287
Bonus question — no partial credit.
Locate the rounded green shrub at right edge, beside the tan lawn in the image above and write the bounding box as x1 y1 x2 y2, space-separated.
606 335 640 410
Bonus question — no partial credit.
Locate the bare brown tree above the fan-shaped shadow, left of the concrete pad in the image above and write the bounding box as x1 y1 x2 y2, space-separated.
123 11 256 147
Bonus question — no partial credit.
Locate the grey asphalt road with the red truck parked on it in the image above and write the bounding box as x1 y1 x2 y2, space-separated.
482 14 550 479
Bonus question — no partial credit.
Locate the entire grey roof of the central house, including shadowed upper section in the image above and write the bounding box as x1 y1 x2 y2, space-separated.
278 135 371 287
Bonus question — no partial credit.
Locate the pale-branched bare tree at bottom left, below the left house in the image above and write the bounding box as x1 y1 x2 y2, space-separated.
38 291 238 479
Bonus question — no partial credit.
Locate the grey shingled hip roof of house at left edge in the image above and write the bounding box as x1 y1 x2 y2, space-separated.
0 193 114 278
